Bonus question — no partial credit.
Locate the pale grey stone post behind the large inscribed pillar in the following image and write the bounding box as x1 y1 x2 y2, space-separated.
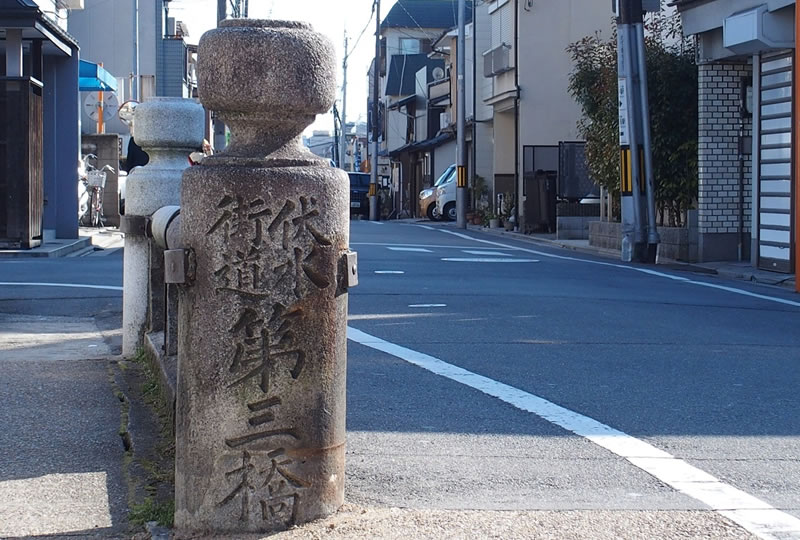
120 98 205 356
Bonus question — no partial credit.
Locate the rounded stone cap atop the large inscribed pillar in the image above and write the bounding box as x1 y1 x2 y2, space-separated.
197 19 336 157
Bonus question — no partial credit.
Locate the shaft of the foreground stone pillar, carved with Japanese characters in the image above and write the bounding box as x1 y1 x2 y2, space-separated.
176 167 349 531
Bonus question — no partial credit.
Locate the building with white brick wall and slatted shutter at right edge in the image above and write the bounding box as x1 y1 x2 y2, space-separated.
676 0 800 280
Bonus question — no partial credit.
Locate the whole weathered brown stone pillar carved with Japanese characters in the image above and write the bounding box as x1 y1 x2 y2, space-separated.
174 19 356 535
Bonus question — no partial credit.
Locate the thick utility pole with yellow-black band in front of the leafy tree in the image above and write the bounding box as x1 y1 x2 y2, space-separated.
617 0 659 263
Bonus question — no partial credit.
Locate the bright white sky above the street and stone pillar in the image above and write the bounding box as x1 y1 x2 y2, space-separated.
169 0 396 134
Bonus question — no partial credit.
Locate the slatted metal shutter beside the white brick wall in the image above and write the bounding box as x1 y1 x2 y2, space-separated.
758 52 795 273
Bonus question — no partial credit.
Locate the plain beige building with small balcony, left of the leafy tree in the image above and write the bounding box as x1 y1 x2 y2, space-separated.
478 0 613 231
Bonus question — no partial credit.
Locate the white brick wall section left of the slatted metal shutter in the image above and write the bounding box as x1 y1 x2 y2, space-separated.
698 63 752 261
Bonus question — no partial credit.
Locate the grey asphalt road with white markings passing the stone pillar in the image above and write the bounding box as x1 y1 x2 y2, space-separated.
0 222 800 538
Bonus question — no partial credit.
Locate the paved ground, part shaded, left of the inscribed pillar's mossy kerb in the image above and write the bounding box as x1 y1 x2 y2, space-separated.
0 314 127 538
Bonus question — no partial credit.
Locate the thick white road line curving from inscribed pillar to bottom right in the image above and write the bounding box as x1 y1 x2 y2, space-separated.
347 326 800 540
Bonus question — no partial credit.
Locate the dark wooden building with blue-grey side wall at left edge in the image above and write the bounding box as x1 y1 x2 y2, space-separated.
0 0 82 243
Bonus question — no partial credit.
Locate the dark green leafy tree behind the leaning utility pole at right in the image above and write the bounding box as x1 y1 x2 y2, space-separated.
567 6 697 226
